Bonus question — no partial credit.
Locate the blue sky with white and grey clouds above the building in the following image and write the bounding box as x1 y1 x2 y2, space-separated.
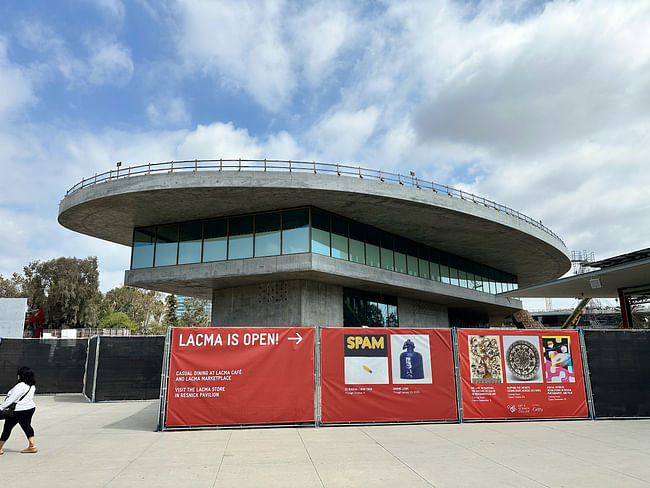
0 0 650 310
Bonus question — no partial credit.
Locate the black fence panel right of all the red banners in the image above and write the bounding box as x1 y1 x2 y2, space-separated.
583 330 650 418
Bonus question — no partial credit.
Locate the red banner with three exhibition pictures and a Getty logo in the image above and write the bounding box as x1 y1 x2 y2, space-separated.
458 329 589 419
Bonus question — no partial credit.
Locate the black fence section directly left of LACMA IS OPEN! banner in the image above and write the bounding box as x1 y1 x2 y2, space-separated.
84 336 165 402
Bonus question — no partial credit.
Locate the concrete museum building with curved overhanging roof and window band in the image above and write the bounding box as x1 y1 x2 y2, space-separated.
59 160 570 327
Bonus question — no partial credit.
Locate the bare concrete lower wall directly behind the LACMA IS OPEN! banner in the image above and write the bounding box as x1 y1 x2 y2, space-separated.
212 280 343 327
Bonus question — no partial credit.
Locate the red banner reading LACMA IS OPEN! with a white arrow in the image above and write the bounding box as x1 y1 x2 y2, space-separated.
165 327 315 427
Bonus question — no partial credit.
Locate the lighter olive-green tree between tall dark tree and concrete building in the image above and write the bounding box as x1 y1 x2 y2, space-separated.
101 286 165 334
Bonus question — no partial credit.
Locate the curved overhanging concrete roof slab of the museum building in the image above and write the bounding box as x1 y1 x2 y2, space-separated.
59 171 570 286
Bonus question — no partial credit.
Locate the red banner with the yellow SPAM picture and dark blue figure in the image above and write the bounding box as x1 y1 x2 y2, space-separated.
320 328 458 424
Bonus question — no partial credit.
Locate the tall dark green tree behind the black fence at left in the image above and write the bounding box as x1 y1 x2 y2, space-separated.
22 256 101 329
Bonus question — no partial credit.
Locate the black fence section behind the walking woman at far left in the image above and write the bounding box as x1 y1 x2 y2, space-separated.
0 339 88 393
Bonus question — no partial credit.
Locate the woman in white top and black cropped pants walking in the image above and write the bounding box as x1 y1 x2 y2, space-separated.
0 367 38 454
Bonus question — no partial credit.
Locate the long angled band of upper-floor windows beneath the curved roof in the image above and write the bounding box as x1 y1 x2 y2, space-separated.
131 208 517 298
